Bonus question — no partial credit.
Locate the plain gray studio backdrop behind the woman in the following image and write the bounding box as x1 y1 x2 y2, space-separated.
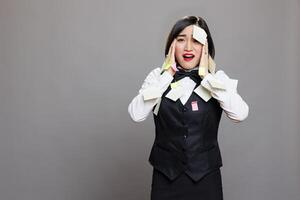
0 0 300 200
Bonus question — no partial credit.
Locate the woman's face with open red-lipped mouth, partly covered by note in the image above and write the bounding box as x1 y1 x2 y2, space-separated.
175 25 203 69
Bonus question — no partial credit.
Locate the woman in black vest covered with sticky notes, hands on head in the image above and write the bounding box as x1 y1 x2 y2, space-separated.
128 16 249 200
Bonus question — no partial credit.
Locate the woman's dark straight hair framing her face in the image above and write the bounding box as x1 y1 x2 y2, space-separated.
165 16 215 58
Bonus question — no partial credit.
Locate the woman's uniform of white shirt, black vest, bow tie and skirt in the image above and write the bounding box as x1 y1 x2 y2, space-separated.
128 65 249 200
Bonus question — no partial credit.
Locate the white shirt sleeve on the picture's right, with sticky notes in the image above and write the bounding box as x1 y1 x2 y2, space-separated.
201 70 249 122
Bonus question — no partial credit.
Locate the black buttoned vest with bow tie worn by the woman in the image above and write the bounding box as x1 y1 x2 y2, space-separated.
148 70 222 181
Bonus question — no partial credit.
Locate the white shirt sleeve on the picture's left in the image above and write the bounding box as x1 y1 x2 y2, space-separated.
128 68 173 122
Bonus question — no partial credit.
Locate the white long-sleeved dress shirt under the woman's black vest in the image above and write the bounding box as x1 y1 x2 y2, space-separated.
128 68 249 122
